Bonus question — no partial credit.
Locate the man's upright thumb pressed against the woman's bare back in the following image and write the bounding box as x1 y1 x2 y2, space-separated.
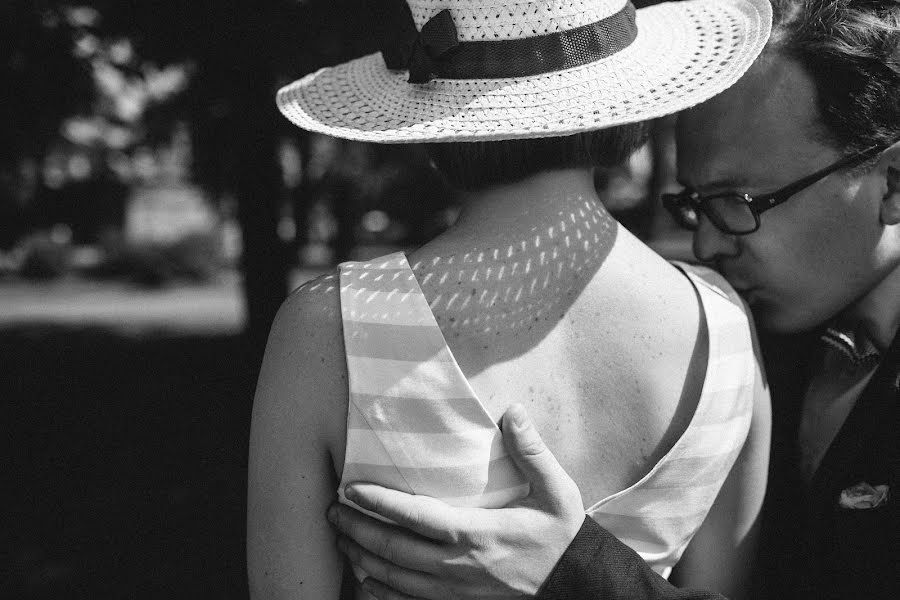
503 404 578 500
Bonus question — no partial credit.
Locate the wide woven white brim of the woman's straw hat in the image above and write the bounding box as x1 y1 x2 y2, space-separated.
277 0 772 143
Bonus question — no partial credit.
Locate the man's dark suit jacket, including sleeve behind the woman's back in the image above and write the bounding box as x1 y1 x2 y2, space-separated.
538 334 900 600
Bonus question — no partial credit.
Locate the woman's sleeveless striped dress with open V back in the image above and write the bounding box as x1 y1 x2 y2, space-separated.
338 253 754 576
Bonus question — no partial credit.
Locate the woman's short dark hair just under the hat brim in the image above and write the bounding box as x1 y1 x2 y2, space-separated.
427 123 649 191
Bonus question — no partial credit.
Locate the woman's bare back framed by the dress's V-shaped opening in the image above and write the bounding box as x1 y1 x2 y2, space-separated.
410 220 707 505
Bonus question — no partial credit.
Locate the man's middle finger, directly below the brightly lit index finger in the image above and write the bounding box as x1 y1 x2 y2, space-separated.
328 504 442 571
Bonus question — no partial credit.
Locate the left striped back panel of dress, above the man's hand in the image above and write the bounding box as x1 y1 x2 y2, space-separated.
338 253 528 520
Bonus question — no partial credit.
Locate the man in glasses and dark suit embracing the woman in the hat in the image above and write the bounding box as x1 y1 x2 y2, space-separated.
330 0 900 600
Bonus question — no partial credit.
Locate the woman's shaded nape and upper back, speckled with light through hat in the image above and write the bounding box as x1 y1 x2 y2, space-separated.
410 170 619 368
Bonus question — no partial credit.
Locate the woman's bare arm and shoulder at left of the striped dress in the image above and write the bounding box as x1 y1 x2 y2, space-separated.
247 274 356 598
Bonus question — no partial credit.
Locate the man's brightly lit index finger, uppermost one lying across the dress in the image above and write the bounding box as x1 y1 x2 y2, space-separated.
344 483 458 542
